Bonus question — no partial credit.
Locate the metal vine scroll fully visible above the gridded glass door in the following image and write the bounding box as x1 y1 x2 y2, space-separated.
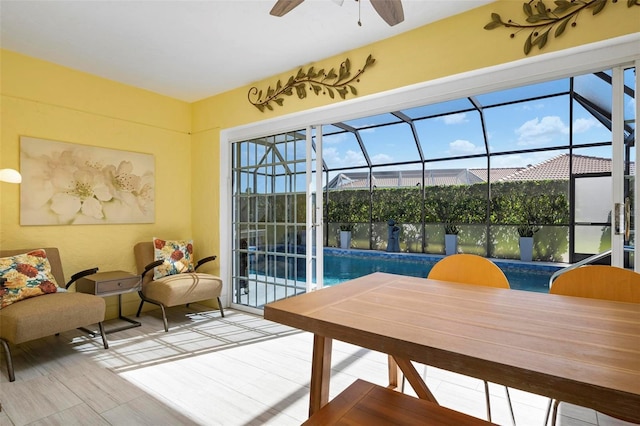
247 55 376 112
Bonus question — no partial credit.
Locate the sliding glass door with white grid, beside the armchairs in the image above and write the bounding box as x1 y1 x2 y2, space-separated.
232 127 322 309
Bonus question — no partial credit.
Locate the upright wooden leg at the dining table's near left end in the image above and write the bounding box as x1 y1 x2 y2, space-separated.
309 334 333 417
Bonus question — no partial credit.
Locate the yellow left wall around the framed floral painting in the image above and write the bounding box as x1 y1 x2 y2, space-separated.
0 51 192 314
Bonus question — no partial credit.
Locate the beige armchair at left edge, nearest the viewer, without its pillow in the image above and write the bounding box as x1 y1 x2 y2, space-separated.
0 248 109 382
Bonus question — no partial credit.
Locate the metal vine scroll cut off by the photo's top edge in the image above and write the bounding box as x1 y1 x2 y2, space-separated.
484 0 640 55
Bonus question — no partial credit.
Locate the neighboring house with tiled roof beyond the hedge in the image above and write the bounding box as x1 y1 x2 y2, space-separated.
328 154 635 190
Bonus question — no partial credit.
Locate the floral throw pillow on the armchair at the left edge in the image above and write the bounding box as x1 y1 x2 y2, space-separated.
0 249 59 309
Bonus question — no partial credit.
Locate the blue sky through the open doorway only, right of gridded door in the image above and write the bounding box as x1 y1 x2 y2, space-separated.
323 71 636 173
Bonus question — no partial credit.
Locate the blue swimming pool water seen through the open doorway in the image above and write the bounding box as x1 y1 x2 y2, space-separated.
323 248 563 293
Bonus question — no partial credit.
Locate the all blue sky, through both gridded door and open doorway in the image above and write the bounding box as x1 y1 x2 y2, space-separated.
240 69 637 192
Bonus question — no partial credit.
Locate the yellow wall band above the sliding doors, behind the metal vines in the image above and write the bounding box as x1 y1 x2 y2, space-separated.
193 0 640 134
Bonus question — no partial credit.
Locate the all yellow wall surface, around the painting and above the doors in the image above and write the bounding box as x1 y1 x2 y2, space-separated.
0 0 640 316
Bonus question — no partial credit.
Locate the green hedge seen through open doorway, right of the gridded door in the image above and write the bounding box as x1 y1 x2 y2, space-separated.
326 180 569 225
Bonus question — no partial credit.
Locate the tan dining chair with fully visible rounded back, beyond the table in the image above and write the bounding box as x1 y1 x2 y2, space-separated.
422 254 516 425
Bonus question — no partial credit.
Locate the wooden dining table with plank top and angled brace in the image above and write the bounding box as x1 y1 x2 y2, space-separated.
264 272 640 422
